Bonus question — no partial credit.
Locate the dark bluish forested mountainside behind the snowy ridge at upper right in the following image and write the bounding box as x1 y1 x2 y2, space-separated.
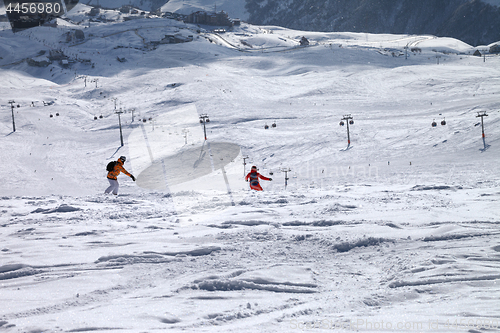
245 0 500 46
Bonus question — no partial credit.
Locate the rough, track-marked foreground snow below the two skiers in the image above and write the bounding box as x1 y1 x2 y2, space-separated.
0 185 500 331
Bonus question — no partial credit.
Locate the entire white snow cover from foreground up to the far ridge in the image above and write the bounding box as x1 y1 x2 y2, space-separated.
0 4 500 333
